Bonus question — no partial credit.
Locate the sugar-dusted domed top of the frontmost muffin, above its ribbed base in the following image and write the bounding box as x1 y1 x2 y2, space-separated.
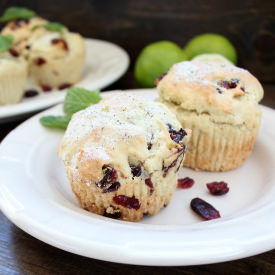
58 93 190 187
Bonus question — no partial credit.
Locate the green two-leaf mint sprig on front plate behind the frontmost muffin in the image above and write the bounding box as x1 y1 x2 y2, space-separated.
39 87 102 129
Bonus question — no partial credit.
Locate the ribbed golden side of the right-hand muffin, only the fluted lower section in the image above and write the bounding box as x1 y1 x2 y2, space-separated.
183 119 258 172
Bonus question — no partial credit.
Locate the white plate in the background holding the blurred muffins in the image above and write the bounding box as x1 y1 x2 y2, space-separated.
0 38 129 123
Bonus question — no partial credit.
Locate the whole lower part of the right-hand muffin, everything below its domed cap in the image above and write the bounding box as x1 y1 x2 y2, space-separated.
162 101 261 172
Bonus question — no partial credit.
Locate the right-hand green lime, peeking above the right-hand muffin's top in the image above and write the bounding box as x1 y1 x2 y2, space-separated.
183 33 237 64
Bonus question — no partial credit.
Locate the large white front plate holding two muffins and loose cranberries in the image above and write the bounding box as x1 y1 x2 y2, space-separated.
0 90 275 265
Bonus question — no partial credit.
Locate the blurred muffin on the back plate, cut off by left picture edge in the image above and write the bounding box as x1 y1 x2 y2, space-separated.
0 49 28 105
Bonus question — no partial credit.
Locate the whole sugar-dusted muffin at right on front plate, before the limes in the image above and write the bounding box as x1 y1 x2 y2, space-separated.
157 60 263 171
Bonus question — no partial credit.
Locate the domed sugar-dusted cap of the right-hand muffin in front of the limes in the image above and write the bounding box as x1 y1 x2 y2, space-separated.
157 60 263 123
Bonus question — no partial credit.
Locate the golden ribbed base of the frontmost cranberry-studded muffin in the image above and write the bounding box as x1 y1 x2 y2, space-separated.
67 166 180 222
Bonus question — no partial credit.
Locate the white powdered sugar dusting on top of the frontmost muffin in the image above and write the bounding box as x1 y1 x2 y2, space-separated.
60 93 181 171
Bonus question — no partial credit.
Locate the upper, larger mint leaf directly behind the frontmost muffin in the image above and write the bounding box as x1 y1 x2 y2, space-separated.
63 87 102 115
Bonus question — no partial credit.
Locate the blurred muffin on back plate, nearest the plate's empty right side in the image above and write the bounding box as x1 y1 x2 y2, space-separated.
25 27 85 88
